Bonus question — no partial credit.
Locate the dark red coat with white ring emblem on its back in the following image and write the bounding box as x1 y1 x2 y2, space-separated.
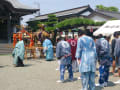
68 39 77 60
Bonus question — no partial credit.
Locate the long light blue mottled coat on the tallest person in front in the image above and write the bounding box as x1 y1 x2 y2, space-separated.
76 35 97 73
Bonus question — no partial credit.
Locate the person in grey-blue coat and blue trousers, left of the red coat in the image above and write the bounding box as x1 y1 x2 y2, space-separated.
56 38 73 82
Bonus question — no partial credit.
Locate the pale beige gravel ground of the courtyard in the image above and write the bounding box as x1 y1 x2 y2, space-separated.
0 55 120 90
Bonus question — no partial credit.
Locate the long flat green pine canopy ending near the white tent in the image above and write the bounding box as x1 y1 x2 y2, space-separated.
56 18 105 29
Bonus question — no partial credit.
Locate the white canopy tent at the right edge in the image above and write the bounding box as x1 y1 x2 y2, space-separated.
93 20 120 36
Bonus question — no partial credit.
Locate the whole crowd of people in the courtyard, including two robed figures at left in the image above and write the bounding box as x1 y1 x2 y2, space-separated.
13 30 120 90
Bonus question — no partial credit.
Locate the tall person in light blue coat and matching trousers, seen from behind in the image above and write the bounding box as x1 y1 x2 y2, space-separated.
76 30 97 90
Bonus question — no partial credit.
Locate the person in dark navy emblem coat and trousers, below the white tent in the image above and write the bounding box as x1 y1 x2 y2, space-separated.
96 34 111 87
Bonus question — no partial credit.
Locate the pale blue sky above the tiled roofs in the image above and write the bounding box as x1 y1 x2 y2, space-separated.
19 0 120 24
